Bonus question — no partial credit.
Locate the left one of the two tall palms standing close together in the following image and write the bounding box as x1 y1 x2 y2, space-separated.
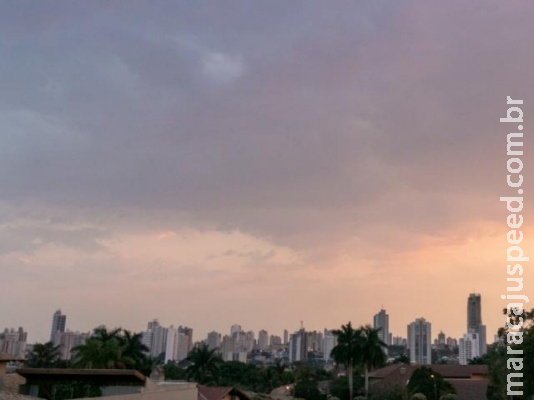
330 322 362 400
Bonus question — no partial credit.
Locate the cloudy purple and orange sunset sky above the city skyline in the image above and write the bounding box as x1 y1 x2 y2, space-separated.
0 0 534 342
